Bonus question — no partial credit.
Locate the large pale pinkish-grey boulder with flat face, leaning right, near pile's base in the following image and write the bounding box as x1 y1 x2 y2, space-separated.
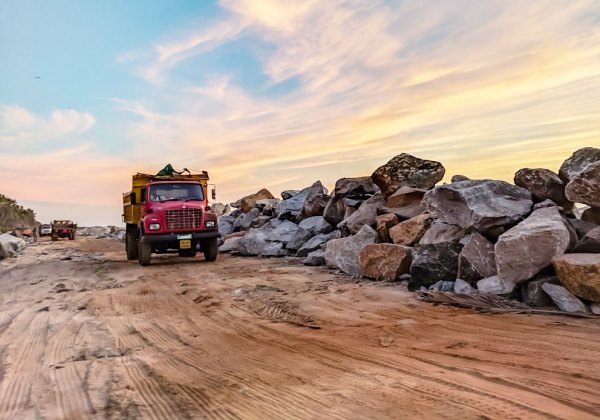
495 207 571 284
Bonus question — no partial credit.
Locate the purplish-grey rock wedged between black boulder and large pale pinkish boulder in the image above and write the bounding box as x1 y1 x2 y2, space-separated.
458 232 497 283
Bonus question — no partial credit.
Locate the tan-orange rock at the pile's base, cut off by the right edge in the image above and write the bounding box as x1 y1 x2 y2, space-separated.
552 254 600 302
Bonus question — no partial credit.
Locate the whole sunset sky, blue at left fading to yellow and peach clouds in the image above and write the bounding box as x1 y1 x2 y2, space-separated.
0 0 600 226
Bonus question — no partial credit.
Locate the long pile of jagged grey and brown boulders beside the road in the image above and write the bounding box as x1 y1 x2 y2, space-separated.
215 147 600 313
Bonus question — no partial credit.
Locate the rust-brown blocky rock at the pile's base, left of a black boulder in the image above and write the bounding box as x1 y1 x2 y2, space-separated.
358 244 412 281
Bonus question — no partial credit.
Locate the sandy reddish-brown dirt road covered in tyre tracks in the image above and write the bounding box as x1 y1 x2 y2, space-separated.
0 238 600 419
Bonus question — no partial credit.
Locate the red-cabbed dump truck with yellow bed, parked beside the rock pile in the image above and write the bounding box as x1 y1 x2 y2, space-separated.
123 165 221 266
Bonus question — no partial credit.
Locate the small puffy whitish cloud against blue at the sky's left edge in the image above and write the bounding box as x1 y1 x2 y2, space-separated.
0 104 96 144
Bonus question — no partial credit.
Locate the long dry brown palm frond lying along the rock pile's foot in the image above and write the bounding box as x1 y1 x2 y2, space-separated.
416 291 599 318
